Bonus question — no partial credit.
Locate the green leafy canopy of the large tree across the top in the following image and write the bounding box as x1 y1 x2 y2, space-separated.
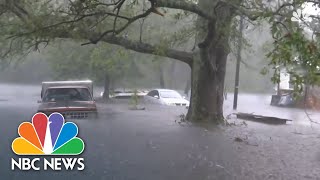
0 0 319 86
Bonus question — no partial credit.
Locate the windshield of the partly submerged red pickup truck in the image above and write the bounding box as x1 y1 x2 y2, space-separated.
43 88 92 102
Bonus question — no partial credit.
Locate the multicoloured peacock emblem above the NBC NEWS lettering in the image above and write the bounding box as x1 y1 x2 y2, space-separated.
12 113 84 155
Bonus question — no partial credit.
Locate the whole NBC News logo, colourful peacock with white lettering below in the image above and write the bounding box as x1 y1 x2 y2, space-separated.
11 113 85 171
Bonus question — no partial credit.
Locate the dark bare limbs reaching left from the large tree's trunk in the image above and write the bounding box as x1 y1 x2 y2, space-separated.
4 0 200 65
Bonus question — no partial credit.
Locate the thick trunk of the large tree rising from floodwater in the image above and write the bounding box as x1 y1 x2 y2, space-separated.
187 0 232 123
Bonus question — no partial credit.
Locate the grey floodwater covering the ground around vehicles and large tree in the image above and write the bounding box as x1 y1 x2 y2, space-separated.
0 85 320 180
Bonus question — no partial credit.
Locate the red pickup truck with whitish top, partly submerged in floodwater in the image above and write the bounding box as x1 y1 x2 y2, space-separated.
38 80 98 119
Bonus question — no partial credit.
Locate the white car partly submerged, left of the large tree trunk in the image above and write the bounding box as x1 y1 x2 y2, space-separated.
145 89 190 107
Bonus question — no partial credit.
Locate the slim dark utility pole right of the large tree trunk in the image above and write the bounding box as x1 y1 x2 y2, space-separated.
233 16 244 110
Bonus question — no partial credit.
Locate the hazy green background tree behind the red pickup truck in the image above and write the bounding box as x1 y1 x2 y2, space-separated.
46 41 139 99
